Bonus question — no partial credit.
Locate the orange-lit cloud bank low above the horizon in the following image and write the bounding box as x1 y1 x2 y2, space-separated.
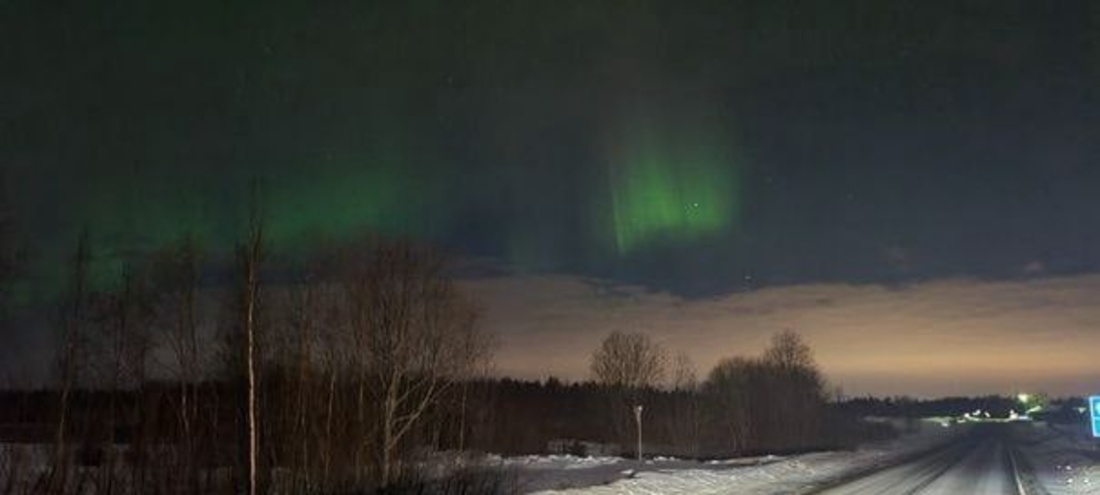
466 275 1100 395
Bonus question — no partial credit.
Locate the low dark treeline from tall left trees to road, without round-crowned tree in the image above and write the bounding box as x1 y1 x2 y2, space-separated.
440 332 897 459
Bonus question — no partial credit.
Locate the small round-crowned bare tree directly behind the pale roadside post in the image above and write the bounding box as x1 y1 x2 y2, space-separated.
592 331 667 459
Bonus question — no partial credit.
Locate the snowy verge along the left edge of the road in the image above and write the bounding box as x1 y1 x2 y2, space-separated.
503 421 966 495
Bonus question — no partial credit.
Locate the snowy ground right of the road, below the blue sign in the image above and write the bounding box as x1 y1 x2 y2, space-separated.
1016 421 1100 495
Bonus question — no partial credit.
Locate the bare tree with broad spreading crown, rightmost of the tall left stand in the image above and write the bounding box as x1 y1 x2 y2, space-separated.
343 241 491 486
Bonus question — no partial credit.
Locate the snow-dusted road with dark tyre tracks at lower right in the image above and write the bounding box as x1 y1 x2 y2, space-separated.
815 424 1031 495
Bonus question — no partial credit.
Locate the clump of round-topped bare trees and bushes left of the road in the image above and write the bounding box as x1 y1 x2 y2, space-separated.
567 330 889 458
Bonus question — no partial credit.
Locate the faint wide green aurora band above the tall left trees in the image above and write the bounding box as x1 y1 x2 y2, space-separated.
32 153 440 297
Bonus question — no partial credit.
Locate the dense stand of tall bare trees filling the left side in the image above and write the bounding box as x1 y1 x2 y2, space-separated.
0 228 493 494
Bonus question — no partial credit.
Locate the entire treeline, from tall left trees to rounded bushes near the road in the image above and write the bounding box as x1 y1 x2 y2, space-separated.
0 217 886 494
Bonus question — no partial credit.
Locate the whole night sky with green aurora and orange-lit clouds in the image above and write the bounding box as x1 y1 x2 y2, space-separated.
0 0 1100 394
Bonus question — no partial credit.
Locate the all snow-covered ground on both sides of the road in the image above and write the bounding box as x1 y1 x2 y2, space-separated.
0 421 1100 495
